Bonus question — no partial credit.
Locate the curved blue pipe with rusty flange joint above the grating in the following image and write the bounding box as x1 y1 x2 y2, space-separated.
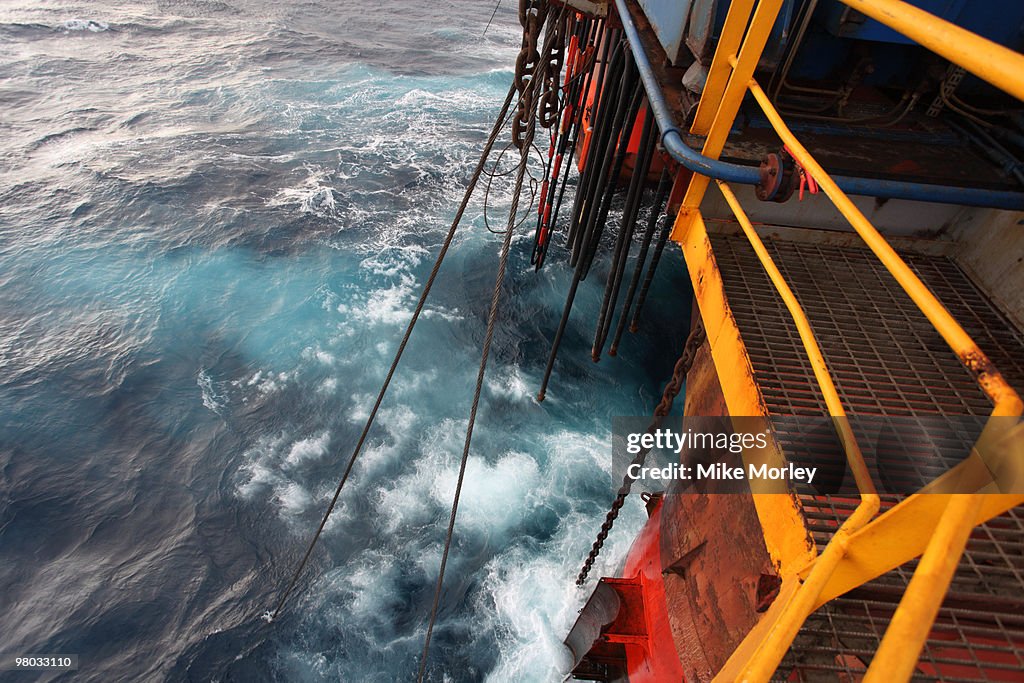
615 0 1024 211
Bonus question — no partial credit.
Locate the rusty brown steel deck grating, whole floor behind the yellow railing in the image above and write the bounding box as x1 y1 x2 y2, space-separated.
711 234 1024 683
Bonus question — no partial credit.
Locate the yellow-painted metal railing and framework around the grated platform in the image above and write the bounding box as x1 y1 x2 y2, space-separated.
659 0 1024 683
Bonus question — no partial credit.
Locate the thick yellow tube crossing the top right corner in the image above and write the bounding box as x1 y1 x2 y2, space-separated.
840 0 1024 99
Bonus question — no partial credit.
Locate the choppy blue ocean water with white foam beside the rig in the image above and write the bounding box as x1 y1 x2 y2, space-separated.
0 0 689 682
